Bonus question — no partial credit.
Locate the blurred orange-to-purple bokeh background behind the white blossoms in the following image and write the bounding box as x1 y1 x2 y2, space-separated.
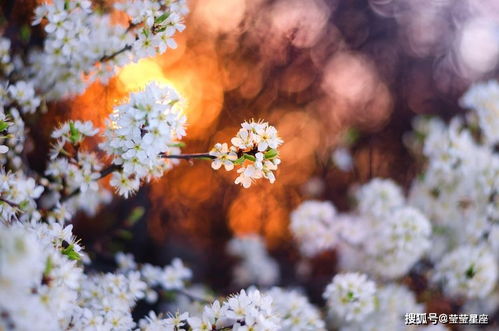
1 0 499 311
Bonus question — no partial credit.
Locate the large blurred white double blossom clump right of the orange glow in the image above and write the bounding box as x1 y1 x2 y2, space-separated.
290 183 431 278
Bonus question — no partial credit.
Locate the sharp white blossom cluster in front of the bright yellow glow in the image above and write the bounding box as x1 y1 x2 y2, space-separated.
100 83 186 197
